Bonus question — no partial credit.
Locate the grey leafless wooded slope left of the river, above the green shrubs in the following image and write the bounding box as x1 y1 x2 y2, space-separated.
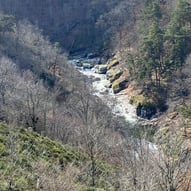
0 15 124 149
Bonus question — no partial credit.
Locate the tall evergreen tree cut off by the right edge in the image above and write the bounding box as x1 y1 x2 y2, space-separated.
165 0 191 75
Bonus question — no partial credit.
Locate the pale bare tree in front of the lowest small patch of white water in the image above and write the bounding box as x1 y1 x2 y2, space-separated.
119 137 158 191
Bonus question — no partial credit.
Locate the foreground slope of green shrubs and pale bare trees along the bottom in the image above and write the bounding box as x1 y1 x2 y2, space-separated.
0 120 190 191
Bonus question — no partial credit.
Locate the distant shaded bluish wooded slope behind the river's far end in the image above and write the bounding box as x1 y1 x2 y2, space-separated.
0 0 137 53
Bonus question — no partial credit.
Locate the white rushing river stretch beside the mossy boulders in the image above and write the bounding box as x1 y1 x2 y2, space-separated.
69 58 138 124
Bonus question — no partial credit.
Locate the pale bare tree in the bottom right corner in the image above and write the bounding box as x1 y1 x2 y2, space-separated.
155 132 191 191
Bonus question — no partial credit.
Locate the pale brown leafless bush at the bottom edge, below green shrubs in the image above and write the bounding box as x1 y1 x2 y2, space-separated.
32 161 80 191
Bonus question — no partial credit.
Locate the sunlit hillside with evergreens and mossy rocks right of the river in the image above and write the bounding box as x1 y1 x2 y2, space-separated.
101 0 191 124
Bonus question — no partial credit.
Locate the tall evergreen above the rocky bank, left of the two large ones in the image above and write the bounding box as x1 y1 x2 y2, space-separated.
135 0 163 86
